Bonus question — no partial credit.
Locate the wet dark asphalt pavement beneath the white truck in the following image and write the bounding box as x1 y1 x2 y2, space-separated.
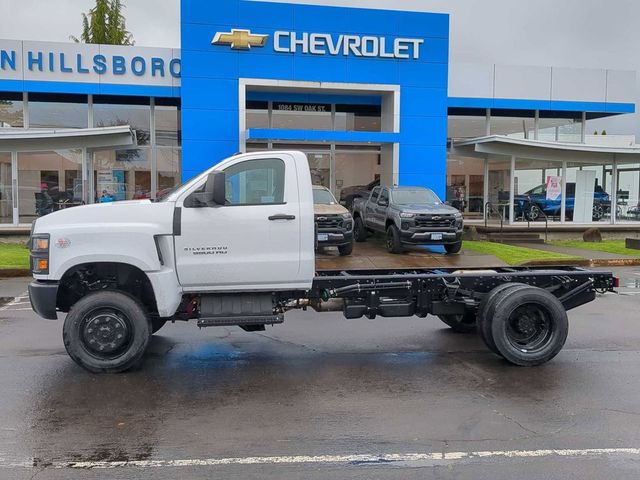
0 269 640 480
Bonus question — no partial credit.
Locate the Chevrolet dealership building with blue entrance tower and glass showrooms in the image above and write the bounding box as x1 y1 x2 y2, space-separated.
0 0 640 228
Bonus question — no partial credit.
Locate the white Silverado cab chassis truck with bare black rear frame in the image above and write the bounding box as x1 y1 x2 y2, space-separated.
29 151 617 372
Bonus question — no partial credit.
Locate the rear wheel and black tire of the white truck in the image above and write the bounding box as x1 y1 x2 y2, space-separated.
491 287 569 367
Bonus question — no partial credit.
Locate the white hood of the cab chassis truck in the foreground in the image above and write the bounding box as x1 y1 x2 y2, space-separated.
34 200 175 235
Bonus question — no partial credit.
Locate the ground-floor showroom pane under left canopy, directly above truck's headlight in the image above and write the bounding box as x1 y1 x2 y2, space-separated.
17 149 82 223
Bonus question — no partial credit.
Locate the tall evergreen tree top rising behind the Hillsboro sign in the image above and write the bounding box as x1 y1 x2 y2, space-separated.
71 0 135 45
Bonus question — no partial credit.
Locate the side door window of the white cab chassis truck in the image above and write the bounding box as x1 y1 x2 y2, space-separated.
224 158 285 205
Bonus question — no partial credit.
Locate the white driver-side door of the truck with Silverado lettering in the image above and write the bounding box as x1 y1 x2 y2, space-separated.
174 153 304 291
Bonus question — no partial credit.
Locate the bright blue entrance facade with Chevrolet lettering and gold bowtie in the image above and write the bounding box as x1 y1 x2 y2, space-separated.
181 0 449 194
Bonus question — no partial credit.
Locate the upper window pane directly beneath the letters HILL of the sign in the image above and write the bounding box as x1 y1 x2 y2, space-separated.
28 93 89 128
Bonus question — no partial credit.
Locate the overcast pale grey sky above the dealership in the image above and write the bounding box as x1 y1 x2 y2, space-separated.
0 0 640 134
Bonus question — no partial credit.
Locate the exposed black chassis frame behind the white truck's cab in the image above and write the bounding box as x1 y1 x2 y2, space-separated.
307 266 618 318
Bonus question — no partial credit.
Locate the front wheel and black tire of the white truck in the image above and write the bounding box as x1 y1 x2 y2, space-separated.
62 291 151 373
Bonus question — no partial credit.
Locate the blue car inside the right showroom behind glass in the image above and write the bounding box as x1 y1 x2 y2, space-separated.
513 183 611 222
